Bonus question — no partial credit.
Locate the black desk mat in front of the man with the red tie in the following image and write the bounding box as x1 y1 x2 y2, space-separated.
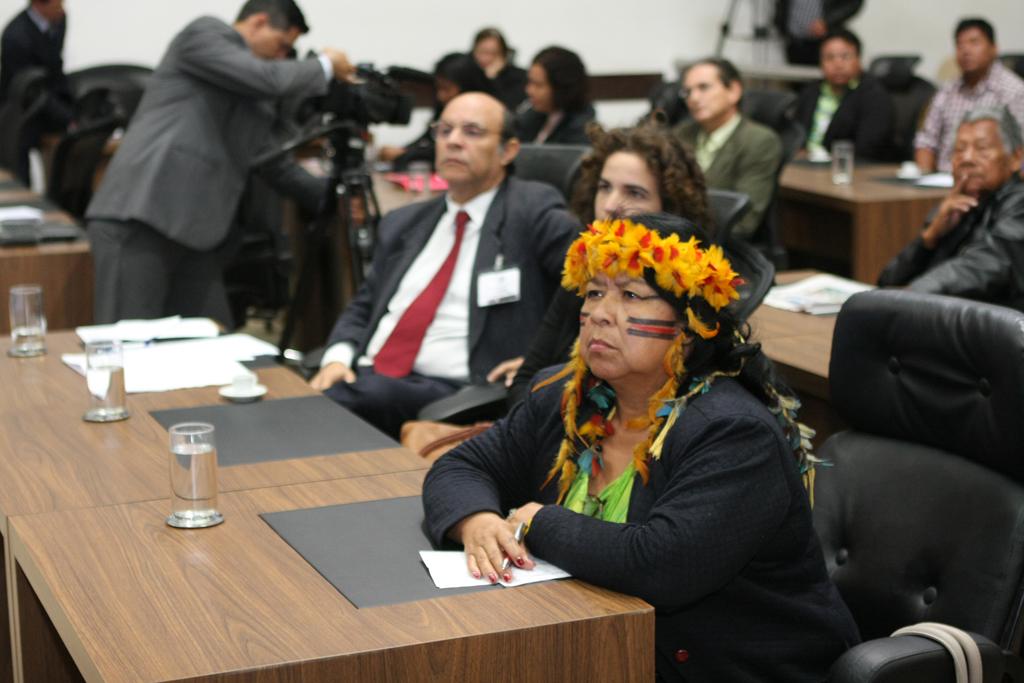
150 396 398 467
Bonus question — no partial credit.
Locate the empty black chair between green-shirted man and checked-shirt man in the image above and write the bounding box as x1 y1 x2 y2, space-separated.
867 54 935 161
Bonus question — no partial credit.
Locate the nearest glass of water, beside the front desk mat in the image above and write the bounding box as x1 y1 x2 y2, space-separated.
167 422 224 528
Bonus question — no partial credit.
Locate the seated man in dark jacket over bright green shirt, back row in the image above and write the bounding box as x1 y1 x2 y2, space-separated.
797 29 893 159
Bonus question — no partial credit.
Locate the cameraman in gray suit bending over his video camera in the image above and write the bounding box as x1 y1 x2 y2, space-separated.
86 0 353 326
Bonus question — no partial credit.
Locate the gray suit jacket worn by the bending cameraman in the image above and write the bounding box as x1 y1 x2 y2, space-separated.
86 16 327 250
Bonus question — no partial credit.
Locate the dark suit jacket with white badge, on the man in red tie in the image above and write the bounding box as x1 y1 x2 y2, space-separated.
328 178 580 381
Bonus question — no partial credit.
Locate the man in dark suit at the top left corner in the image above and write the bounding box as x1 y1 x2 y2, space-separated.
0 0 73 182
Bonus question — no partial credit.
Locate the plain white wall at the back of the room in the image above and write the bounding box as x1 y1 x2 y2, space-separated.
0 0 1024 141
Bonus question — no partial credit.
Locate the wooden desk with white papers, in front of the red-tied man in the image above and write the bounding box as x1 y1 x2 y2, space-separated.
0 332 426 681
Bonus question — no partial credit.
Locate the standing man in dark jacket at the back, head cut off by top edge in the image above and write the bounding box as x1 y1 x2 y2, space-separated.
775 0 864 65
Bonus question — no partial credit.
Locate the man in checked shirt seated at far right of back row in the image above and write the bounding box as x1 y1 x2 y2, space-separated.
913 18 1024 173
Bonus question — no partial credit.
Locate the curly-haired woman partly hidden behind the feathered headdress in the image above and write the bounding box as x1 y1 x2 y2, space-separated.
488 122 711 405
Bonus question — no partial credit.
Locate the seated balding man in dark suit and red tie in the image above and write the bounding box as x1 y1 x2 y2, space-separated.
310 92 579 436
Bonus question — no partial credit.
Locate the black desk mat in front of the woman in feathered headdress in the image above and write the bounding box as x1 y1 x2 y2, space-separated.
260 496 491 609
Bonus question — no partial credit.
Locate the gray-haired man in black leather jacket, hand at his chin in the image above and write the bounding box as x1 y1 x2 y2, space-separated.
879 106 1024 310
